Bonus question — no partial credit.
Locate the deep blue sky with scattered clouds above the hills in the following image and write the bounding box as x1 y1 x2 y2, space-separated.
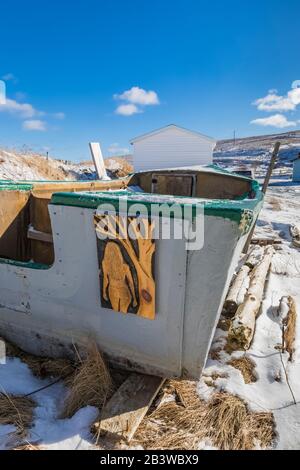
0 0 300 161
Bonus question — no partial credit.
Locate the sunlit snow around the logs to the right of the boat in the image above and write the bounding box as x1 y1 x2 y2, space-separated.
198 185 300 449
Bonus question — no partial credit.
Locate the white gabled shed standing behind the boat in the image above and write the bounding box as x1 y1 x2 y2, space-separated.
130 124 216 171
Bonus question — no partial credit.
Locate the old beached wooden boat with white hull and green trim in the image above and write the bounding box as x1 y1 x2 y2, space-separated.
0 166 262 378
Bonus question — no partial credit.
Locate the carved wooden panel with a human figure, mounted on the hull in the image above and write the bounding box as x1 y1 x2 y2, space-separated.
94 215 155 320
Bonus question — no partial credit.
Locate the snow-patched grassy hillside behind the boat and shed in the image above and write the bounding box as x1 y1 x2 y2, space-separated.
0 130 300 180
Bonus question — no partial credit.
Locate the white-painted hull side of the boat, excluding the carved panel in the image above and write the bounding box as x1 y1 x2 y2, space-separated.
0 205 246 379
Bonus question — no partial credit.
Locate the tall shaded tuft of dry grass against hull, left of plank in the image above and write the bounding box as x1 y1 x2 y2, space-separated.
62 344 113 418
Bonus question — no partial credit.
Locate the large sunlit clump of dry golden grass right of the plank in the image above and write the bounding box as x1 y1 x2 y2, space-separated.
134 381 274 450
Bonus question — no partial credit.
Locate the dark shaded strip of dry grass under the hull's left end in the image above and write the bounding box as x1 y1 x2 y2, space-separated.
0 338 74 378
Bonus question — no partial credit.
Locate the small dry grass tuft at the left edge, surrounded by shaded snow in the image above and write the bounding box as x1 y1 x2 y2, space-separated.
0 393 35 439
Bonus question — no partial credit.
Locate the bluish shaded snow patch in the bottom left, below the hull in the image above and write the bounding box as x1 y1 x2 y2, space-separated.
0 358 98 450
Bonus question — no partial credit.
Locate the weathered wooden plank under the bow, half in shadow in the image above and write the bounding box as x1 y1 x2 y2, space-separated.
94 373 165 442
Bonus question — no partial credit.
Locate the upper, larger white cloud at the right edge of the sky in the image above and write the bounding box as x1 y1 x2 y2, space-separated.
253 80 300 111
